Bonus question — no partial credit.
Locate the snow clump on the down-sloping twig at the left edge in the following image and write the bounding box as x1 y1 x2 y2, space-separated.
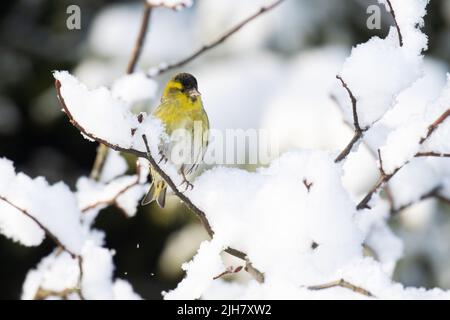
0 158 83 254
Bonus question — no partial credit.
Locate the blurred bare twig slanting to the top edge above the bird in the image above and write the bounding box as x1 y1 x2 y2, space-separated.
149 0 284 77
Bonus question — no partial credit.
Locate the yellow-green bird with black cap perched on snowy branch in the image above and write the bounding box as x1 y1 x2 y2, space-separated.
142 73 209 208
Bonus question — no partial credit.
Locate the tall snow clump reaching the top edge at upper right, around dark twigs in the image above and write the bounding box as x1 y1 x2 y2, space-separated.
337 0 428 128
